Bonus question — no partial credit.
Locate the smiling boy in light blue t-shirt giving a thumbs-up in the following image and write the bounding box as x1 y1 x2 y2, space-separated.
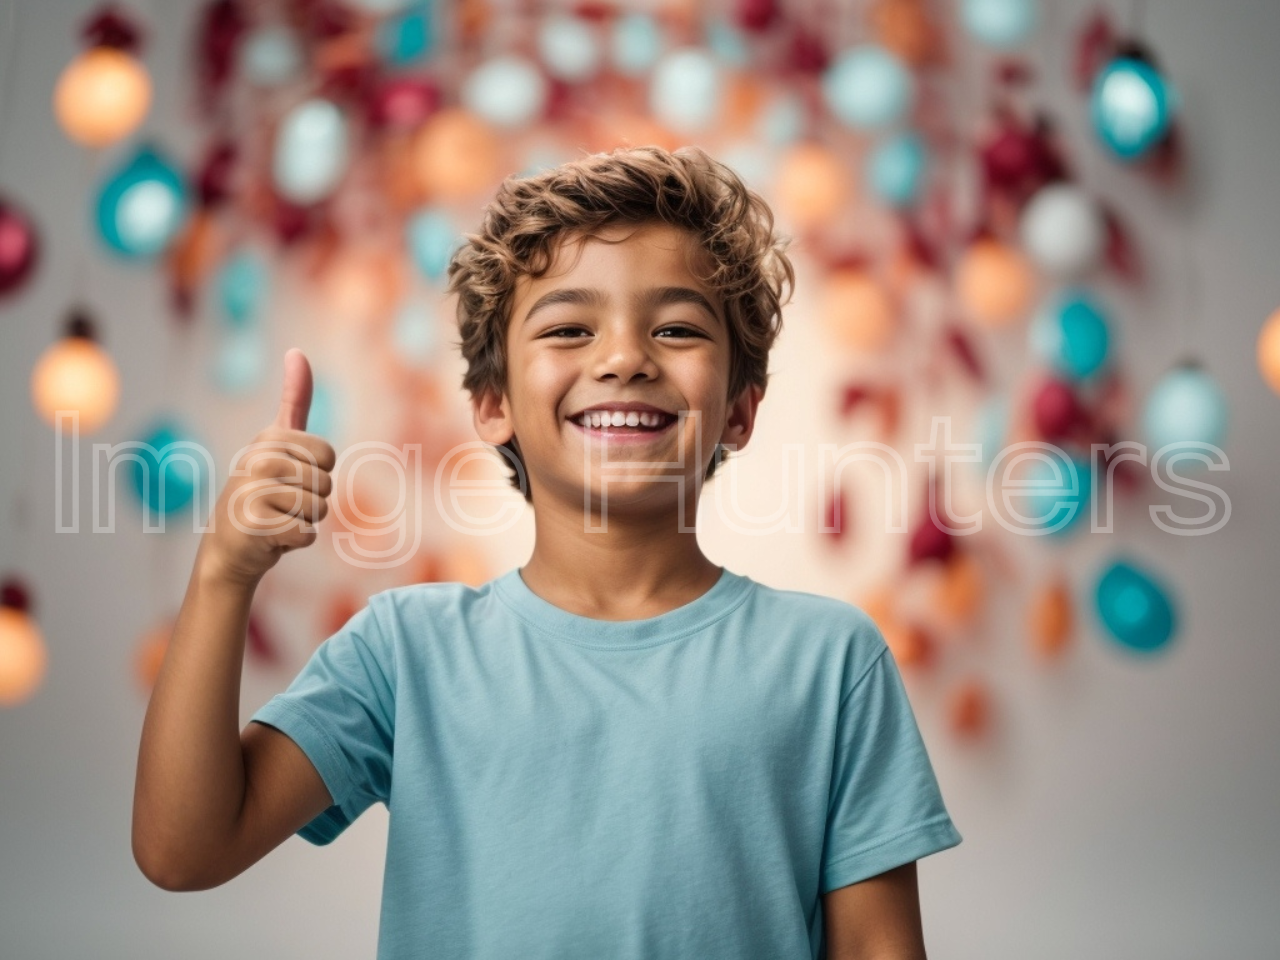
134 147 960 960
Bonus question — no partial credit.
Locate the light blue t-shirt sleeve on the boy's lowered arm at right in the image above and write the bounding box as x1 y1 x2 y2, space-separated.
819 621 961 893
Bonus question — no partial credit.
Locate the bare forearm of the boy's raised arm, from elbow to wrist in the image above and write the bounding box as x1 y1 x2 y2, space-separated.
133 549 256 886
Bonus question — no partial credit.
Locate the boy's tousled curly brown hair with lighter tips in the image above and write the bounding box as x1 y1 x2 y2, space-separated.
448 146 795 500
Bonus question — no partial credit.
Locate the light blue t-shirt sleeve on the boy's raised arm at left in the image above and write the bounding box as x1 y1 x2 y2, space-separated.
250 596 396 846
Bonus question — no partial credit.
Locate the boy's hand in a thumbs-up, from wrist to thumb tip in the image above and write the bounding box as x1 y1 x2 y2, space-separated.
196 348 337 588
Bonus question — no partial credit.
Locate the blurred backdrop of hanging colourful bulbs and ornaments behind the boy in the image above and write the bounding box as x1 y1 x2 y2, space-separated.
0 0 1280 960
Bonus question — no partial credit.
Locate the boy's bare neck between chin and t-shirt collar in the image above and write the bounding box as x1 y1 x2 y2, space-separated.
521 490 721 620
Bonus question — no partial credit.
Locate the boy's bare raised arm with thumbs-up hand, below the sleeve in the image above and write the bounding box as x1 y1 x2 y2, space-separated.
133 351 335 890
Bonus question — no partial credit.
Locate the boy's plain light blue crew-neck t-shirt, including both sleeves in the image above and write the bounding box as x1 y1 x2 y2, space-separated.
253 568 960 960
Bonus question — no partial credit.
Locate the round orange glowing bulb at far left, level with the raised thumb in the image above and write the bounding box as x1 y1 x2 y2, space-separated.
31 335 120 434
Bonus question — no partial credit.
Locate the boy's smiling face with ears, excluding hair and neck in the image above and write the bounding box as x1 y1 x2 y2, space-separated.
475 223 762 522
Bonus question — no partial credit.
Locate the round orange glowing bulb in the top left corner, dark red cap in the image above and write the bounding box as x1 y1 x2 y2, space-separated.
54 46 151 147
